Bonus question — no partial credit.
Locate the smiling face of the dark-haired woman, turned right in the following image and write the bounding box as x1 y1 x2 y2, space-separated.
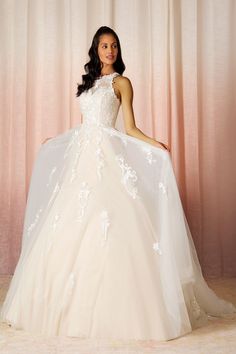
98 34 118 66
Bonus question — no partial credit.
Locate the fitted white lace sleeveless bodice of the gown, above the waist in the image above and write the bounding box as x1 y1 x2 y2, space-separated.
79 72 120 127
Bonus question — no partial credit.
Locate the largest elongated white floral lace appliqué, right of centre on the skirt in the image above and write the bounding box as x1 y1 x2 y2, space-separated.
116 155 138 199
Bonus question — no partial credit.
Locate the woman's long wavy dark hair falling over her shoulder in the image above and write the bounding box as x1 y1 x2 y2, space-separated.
76 26 125 97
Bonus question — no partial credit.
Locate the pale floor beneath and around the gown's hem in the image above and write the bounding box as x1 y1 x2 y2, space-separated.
0 276 236 354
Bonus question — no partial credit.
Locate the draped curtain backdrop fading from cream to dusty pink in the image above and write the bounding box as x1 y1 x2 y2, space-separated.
0 0 236 276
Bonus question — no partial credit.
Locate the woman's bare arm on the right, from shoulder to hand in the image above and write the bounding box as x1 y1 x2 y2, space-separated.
114 76 170 151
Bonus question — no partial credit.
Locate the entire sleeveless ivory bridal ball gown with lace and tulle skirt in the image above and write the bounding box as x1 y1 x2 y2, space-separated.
1 73 236 340
